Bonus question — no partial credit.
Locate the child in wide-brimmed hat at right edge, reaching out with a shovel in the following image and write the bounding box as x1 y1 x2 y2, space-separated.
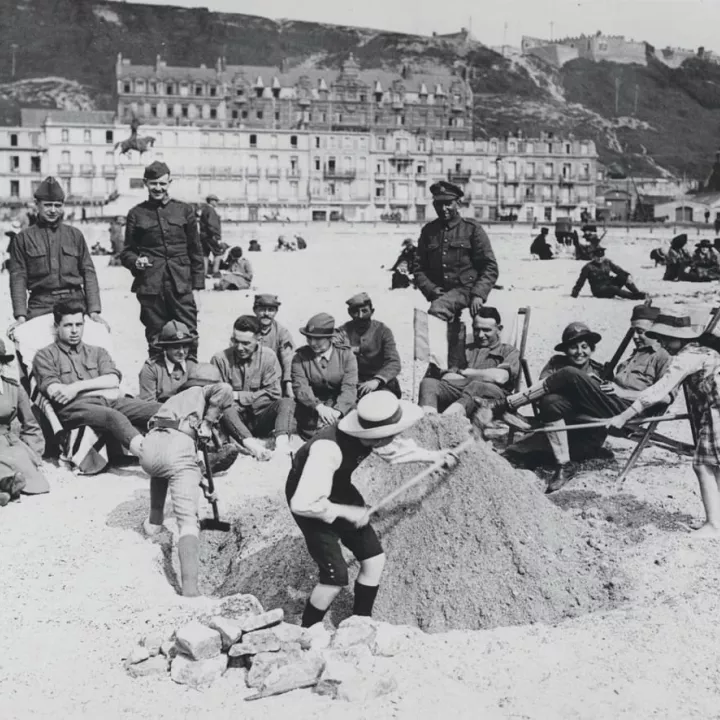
609 313 720 537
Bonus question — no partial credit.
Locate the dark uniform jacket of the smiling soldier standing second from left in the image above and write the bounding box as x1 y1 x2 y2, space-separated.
120 199 205 295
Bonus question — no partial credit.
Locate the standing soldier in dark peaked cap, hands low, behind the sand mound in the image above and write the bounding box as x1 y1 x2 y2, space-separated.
415 180 498 366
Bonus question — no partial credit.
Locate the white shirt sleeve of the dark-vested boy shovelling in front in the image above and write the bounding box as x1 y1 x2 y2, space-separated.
290 440 342 523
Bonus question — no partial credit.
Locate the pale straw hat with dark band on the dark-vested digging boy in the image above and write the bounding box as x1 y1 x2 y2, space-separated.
338 390 423 440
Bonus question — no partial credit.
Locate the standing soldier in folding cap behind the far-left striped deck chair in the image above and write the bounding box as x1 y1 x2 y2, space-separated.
10 177 104 332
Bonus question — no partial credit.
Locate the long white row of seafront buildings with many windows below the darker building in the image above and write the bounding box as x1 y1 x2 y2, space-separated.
0 110 597 222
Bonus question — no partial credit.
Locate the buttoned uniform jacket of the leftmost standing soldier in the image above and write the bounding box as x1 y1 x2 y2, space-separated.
9 222 101 318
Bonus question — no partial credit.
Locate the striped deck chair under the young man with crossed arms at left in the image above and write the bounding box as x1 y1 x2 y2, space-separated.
14 315 120 475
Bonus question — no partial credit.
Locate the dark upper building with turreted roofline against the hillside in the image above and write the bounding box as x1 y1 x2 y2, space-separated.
116 55 473 140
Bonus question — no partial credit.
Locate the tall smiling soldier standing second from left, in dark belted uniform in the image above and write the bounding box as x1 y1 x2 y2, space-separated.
120 161 205 360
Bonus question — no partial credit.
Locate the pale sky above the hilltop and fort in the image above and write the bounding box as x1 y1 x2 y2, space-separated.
143 0 720 52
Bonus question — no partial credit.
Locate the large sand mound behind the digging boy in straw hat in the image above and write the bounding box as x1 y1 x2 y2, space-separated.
218 417 608 632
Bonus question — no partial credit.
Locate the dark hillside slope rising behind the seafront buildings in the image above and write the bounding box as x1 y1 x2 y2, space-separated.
0 0 720 178
